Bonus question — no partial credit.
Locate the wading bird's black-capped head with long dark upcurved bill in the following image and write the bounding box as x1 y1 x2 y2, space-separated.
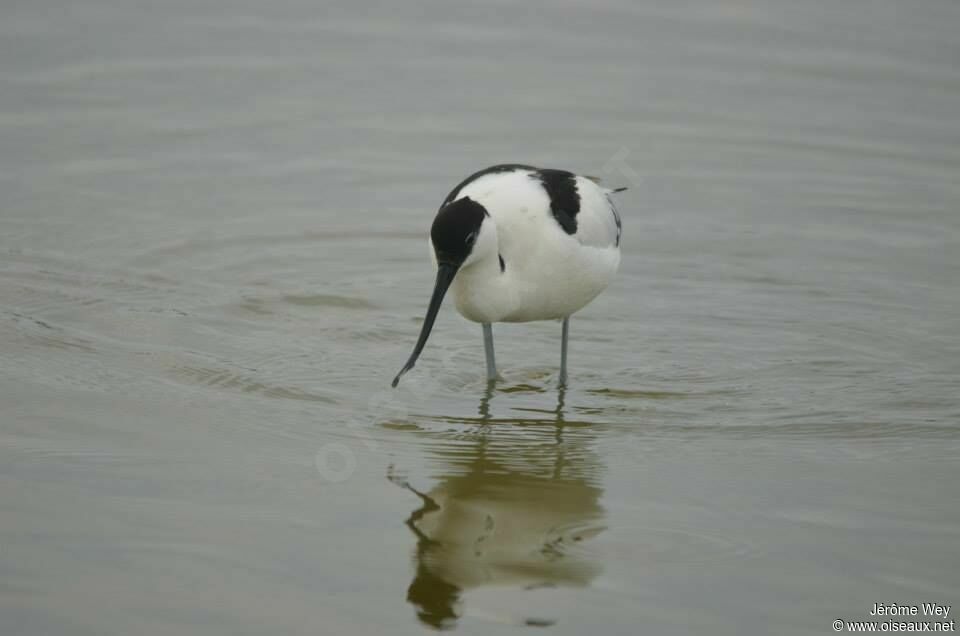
393 197 498 386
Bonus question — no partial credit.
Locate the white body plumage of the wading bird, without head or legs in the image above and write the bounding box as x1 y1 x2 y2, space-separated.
430 169 620 323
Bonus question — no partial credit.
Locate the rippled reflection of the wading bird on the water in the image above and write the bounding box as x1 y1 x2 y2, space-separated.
390 387 603 629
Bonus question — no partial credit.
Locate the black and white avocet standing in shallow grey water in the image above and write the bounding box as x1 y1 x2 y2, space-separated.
393 164 625 386
